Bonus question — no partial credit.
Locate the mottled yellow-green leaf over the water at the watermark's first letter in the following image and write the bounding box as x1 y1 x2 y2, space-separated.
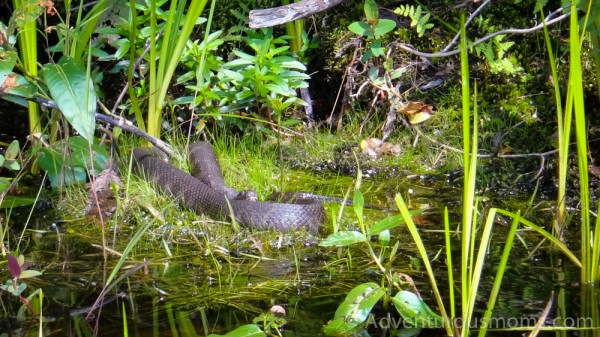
323 282 386 336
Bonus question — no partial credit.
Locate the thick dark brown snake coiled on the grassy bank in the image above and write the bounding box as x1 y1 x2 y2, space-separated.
132 141 326 234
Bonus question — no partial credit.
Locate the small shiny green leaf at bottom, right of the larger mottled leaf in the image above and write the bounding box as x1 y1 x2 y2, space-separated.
392 290 443 328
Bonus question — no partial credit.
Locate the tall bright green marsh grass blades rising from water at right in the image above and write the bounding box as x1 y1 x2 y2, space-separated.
396 11 598 337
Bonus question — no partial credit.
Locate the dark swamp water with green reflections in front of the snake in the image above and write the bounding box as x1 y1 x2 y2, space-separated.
0 166 592 336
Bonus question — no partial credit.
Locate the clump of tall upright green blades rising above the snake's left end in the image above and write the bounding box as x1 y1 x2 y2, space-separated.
99 0 214 138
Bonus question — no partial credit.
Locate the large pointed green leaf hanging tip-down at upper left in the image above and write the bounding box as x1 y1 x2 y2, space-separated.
43 56 96 143
